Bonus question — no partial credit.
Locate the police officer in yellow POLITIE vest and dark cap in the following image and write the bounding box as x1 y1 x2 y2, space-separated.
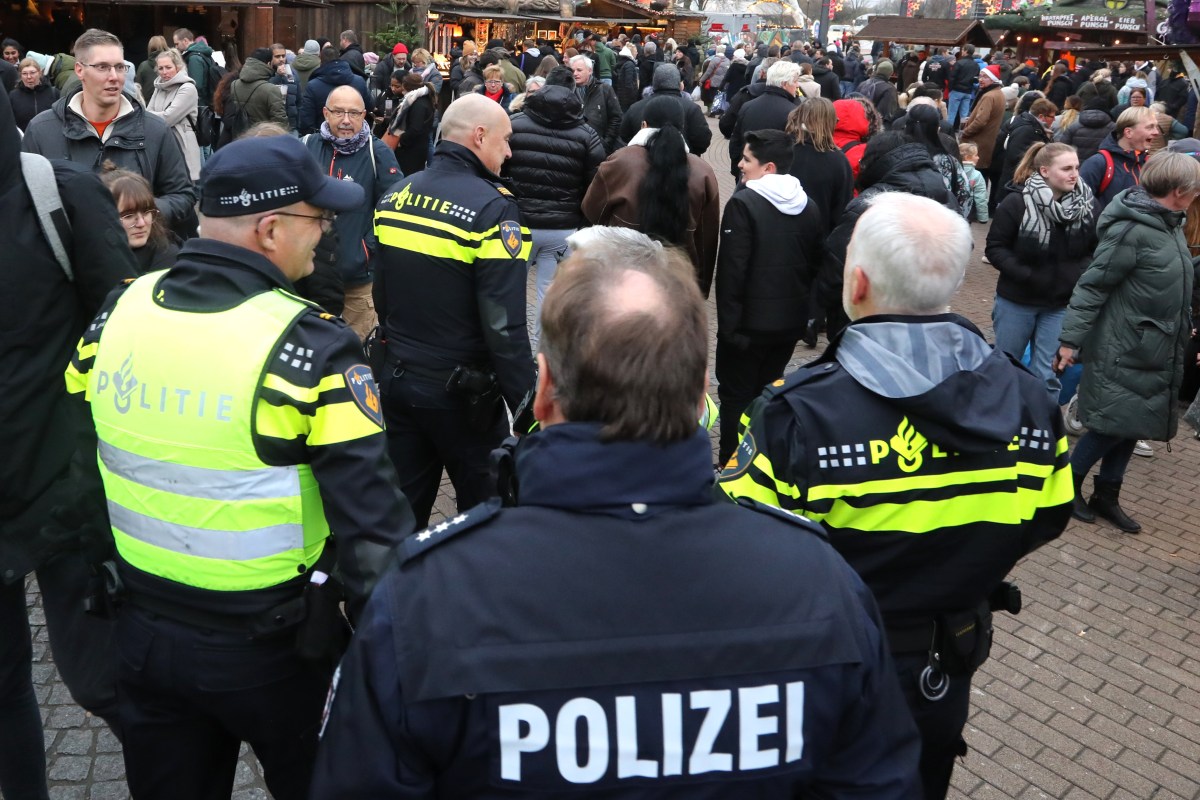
67 137 413 800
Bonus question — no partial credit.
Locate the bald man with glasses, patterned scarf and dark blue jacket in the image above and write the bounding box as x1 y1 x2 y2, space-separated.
304 86 403 338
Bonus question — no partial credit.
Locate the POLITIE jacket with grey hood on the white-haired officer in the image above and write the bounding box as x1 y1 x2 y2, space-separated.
719 314 1086 633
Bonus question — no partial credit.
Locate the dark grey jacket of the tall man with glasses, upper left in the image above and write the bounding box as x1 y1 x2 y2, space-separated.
20 90 196 235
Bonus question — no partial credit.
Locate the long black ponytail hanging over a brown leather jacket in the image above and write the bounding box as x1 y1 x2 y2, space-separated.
637 97 691 245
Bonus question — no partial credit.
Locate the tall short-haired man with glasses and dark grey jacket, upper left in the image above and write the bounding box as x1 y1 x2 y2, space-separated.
22 28 196 237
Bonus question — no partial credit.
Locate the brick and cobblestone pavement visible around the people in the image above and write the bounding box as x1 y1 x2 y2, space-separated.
16 113 1200 800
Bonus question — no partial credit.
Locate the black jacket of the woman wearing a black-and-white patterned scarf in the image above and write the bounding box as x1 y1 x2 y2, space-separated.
984 186 1099 308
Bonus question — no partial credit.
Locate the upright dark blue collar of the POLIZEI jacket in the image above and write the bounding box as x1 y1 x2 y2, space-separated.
516 422 713 519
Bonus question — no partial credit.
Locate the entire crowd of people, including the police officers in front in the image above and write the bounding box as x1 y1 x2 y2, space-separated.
0 17 1200 800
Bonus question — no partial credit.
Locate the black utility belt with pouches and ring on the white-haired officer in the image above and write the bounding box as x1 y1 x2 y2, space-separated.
886 582 1021 700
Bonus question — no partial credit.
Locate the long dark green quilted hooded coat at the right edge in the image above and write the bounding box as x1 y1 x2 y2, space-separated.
1060 187 1195 440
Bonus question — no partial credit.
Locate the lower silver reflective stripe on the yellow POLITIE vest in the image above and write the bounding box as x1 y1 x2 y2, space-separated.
108 500 304 561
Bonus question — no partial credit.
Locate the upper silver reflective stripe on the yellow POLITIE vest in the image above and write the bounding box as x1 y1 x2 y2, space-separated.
100 441 300 503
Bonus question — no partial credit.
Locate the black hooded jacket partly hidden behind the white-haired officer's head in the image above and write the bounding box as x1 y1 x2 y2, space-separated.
817 143 960 337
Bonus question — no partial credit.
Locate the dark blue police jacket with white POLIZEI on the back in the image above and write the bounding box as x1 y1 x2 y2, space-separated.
312 423 919 800
